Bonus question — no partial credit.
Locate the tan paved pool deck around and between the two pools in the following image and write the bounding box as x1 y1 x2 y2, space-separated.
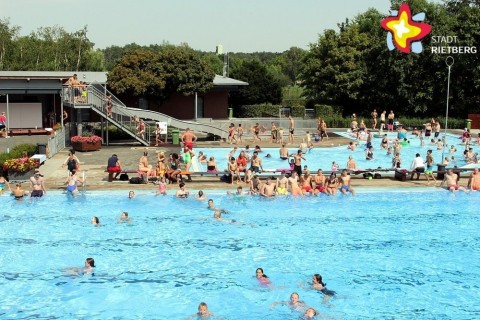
15 129 476 192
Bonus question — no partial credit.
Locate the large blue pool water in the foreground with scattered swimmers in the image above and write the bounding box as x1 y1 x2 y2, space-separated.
0 189 480 320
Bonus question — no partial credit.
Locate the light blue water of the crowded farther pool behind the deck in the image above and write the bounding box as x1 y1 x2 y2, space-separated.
194 133 480 172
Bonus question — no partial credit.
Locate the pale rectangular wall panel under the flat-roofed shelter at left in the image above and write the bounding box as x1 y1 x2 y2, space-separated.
0 102 43 129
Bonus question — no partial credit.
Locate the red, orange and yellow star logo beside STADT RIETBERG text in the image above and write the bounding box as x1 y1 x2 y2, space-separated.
380 3 432 53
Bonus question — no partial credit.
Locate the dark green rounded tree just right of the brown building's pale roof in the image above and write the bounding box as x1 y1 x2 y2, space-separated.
229 60 282 106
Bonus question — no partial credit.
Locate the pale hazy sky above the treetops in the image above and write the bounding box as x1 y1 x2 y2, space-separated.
0 0 438 52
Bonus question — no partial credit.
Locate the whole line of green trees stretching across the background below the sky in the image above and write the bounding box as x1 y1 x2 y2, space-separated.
0 0 480 117
